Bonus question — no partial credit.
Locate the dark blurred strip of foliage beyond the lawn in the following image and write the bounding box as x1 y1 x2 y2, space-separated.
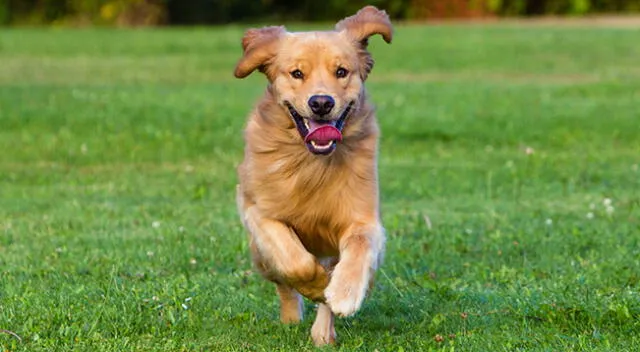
0 0 640 26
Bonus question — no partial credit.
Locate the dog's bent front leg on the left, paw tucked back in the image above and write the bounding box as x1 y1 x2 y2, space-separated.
244 206 329 302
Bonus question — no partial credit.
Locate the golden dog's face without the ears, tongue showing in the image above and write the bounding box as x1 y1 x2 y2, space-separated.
267 33 363 154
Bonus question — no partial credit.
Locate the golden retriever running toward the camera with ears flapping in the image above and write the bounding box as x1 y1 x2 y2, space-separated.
235 6 393 345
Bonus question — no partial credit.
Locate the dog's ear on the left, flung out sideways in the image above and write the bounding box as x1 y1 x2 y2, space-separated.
234 26 286 78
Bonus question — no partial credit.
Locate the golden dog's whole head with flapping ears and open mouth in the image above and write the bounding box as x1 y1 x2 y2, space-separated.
235 6 393 154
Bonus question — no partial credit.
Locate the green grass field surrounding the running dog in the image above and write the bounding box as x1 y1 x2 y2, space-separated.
0 23 640 351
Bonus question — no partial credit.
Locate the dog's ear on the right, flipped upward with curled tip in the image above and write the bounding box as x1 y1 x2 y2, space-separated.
336 6 393 80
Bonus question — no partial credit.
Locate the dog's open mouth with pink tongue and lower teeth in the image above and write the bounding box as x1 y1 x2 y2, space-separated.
285 102 353 155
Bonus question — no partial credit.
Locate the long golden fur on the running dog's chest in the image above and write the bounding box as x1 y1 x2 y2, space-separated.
247 140 378 256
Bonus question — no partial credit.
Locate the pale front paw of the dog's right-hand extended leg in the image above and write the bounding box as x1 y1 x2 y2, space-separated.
324 270 367 317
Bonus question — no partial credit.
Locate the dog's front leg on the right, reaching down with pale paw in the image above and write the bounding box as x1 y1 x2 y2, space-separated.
325 223 385 317
